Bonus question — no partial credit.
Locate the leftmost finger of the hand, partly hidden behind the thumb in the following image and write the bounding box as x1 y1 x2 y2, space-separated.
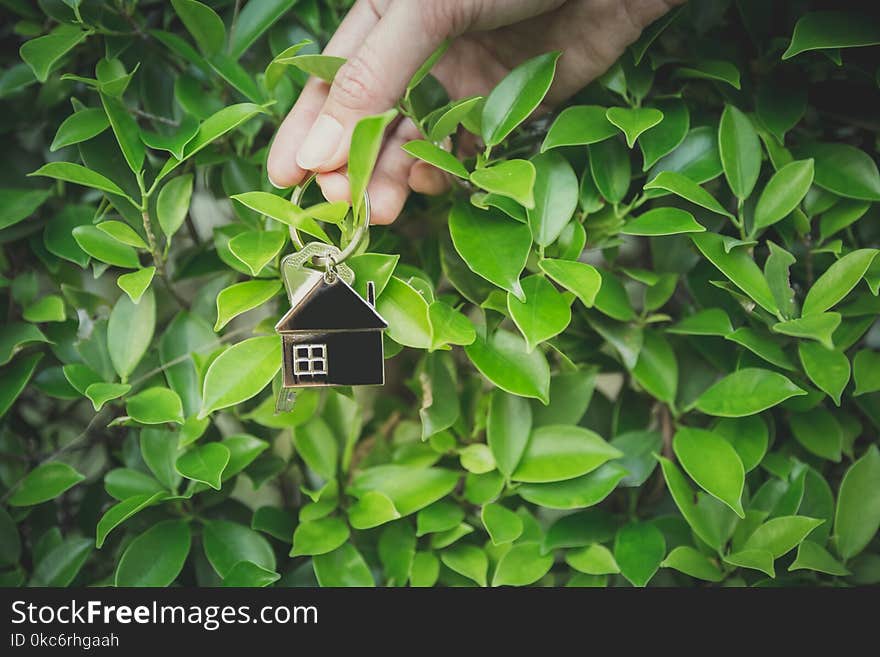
266 1 379 188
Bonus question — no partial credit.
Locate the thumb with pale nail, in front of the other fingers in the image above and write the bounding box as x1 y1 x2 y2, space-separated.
296 0 445 171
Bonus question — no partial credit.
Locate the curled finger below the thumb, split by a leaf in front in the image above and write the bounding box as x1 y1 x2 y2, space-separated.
318 120 421 225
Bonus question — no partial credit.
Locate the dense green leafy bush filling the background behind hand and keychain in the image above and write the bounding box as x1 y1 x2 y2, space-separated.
0 0 880 586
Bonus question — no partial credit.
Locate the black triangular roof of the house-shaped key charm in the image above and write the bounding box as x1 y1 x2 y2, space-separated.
275 271 388 333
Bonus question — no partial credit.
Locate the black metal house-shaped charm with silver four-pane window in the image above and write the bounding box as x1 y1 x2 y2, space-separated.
275 271 388 388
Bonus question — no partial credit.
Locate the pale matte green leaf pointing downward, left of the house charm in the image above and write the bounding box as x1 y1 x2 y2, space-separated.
107 290 156 383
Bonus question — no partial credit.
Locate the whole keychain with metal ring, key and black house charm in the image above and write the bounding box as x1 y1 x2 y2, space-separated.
275 175 388 411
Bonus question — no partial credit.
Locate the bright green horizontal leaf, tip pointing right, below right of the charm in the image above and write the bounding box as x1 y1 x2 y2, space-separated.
511 424 623 483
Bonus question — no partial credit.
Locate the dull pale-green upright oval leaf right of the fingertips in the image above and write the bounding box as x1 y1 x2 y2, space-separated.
526 153 578 246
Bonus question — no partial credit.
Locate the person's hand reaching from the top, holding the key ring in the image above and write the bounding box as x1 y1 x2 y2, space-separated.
267 0 684 224
